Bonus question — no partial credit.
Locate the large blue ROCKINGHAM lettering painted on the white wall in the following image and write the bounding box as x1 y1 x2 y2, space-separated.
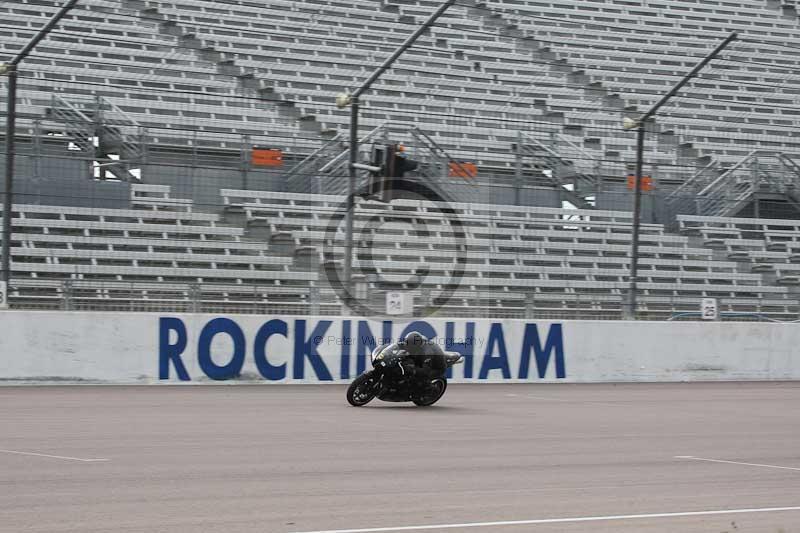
158 317 567 381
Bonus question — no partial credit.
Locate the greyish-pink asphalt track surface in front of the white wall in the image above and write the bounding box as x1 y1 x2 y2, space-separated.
0 383 800 533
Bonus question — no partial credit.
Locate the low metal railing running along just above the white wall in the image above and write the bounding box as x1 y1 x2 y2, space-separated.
3 279 800 321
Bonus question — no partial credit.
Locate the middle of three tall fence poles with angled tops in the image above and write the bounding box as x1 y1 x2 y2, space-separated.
336 0 456 304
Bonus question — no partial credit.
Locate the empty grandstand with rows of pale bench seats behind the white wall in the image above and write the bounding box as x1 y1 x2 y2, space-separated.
0 0 800 319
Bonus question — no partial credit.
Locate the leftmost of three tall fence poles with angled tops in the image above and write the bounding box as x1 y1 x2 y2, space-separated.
0 0 78 298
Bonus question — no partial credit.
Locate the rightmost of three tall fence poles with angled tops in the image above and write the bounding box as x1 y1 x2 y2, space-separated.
623 32 739 320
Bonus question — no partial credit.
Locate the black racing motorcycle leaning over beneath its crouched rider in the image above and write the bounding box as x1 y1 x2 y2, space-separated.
347 343 464 407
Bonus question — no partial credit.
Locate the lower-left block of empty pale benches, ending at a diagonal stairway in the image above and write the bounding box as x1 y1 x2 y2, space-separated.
0 186 336 309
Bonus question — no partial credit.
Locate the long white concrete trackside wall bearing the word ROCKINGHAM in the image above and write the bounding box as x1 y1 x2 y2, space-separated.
0 311 800 383
